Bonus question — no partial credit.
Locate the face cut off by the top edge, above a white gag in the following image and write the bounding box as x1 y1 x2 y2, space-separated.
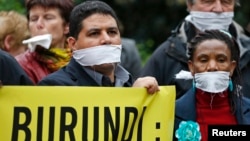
187 0 235 13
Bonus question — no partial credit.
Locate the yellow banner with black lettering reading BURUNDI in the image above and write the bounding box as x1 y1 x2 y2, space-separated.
0 86 175 141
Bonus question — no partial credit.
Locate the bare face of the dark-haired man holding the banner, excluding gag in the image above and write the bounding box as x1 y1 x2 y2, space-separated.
68 14 121 76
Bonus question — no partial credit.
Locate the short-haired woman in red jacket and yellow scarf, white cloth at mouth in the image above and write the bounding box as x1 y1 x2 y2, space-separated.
16 0 74 84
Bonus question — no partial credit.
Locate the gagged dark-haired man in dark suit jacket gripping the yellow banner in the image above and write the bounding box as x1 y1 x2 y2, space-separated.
38 1 159 93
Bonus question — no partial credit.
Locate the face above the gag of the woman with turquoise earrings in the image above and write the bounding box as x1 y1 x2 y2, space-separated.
188 39 236 75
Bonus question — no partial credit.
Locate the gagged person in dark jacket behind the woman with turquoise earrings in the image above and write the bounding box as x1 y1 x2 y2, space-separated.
141 0 250 98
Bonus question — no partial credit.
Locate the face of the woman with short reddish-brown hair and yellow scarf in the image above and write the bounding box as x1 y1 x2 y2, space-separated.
29 5 69 48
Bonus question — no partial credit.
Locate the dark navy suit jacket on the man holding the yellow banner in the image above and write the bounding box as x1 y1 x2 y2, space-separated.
38 58 133 87
